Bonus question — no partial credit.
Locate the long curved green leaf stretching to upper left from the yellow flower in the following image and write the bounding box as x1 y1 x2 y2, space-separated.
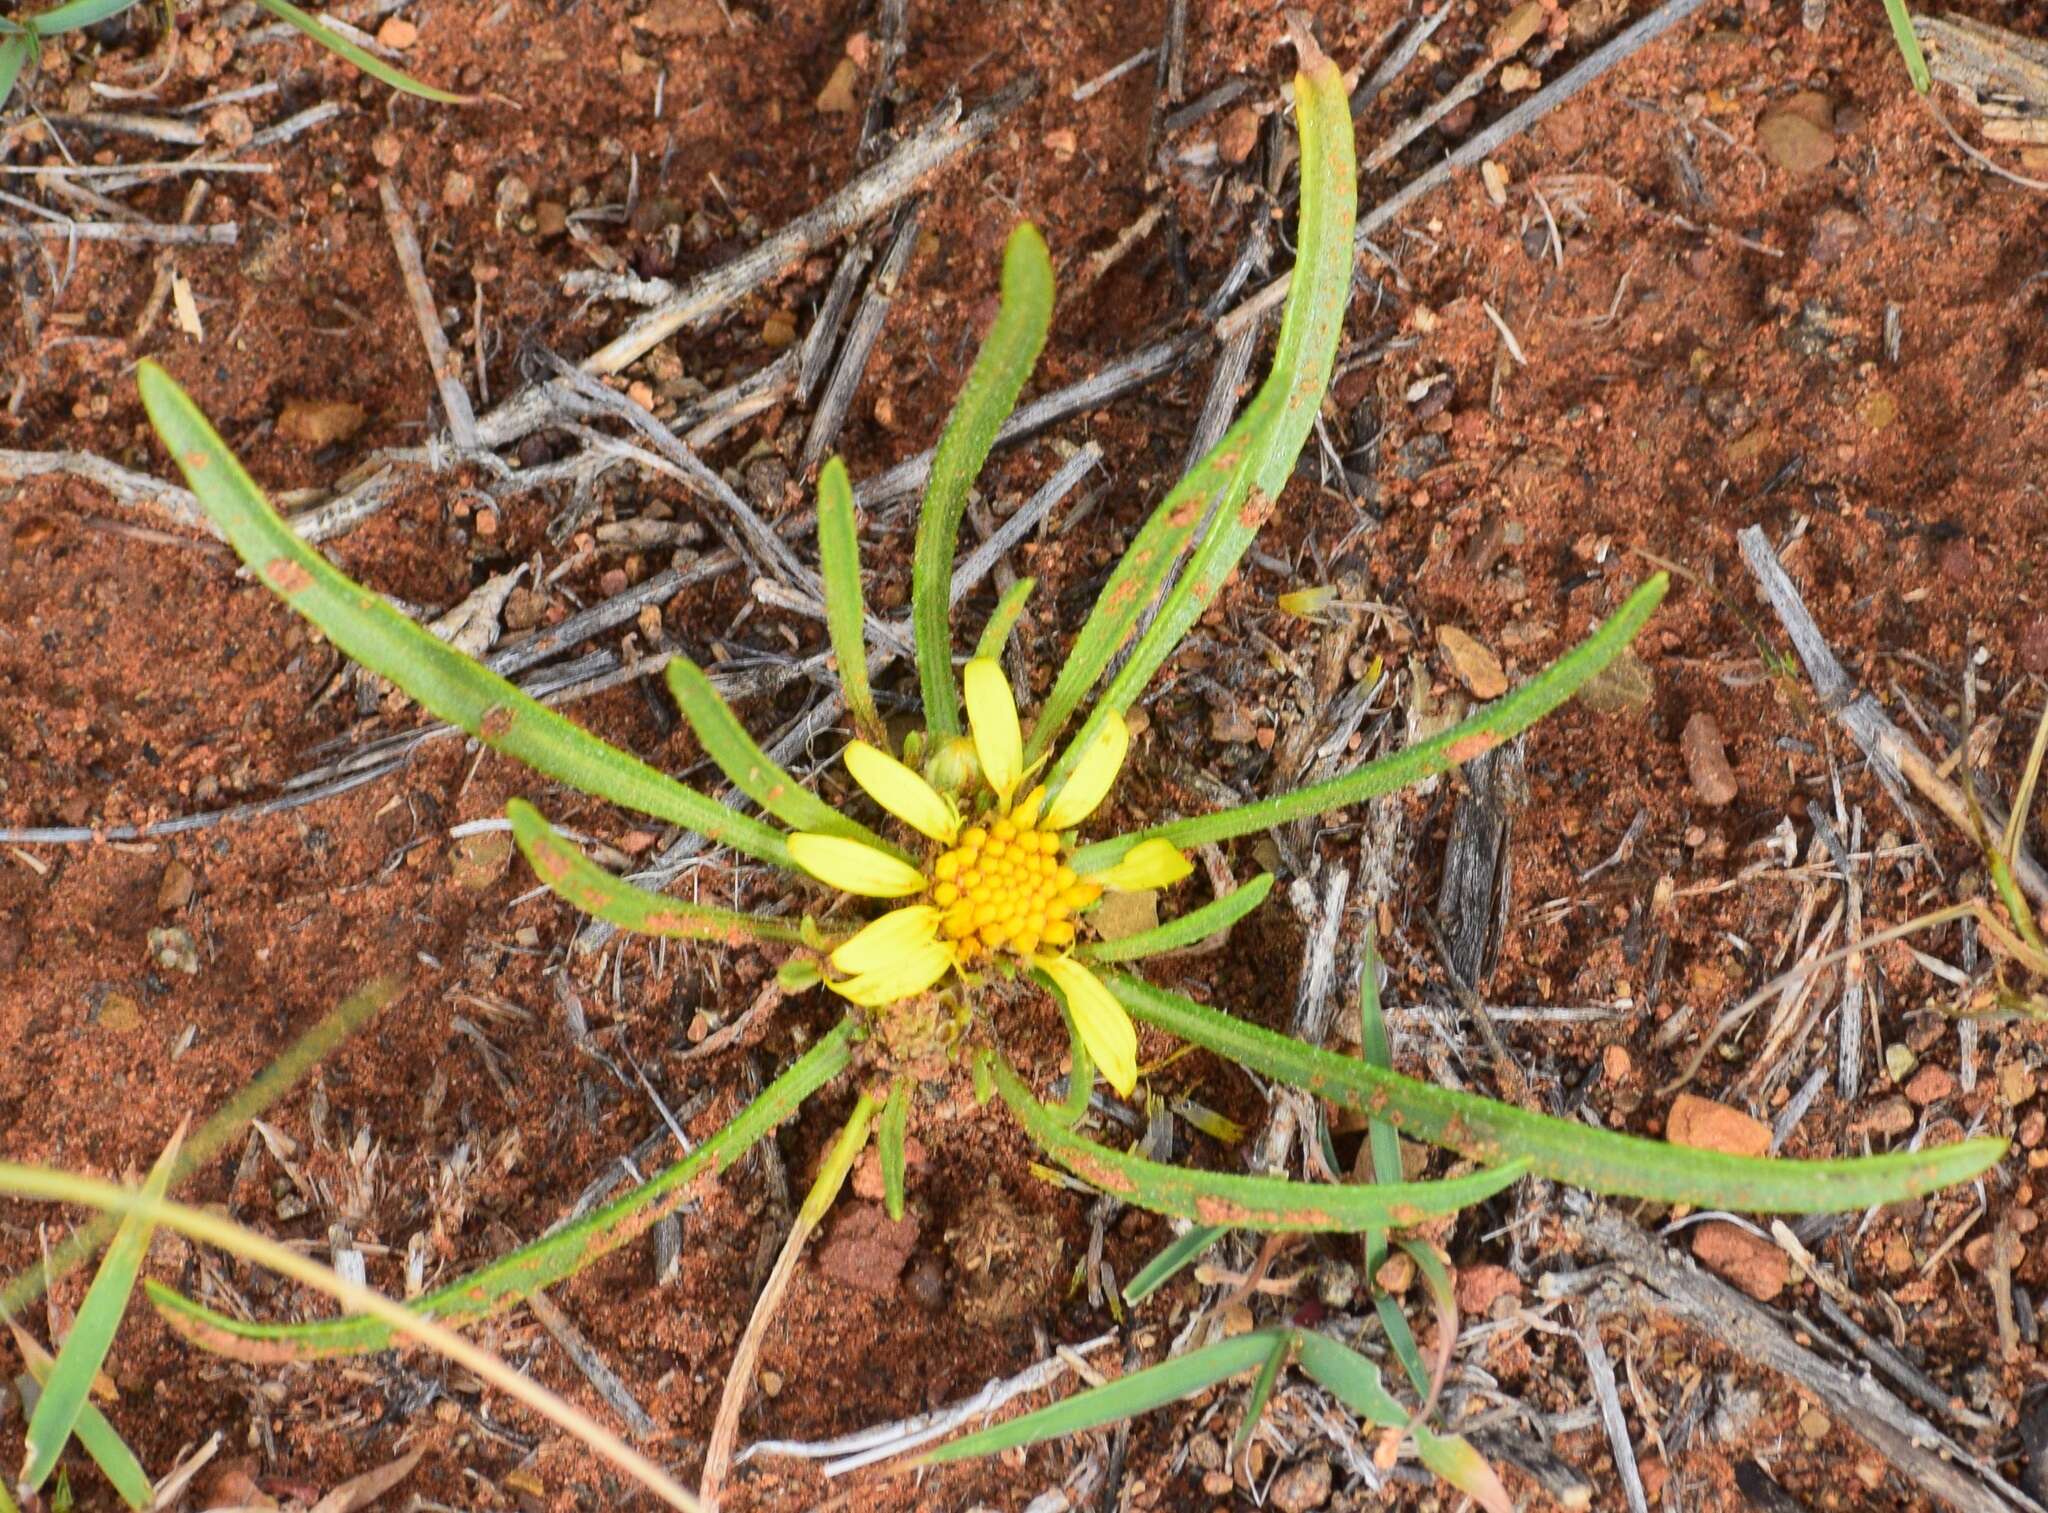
135 358 795 870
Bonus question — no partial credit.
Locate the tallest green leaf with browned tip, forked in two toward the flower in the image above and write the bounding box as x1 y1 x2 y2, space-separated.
1024 43 1358 792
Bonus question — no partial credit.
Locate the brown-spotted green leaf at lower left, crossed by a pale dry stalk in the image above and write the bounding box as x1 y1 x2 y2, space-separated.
143 1022 854 1364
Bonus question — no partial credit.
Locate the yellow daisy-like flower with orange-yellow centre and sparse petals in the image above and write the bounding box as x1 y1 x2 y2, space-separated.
788 657 1192 1095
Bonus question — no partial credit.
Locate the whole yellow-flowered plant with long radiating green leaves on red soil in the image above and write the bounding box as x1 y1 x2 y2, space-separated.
123 23 2005 1506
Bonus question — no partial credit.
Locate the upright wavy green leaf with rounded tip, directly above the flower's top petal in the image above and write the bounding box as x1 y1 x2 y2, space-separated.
909 221 1053 739
